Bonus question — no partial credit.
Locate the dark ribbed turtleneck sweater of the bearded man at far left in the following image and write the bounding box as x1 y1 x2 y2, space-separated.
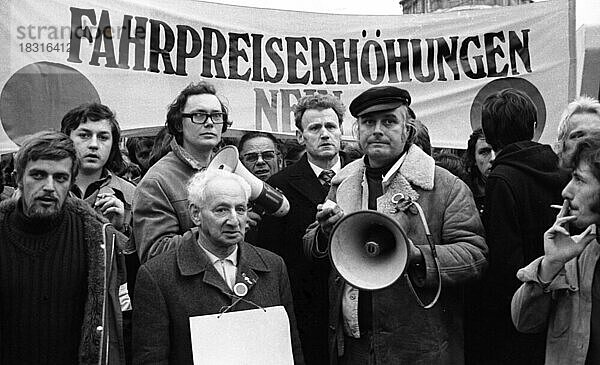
0 201 87 364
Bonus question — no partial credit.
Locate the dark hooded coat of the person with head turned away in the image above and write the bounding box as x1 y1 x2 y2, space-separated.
474 141 568 364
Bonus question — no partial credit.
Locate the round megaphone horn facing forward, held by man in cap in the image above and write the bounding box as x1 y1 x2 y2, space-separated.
329 210 409 290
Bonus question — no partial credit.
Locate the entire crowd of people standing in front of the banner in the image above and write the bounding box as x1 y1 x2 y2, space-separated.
0 82 600 365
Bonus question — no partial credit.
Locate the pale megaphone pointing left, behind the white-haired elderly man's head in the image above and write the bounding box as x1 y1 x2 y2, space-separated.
207 146 290 217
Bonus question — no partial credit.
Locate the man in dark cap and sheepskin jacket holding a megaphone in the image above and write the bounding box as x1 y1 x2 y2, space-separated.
304 86 487 364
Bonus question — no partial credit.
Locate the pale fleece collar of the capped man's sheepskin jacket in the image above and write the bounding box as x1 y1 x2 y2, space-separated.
331 144 435 190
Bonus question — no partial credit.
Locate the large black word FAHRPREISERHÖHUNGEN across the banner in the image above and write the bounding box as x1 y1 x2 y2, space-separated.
67 7 532 87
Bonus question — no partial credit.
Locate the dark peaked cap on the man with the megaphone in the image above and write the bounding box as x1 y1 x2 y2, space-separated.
350 86 411 118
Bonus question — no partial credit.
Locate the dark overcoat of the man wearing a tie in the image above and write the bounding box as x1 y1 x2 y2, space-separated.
256 154 340 364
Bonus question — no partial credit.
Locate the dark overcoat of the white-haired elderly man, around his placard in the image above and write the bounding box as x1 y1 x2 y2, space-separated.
133 229 304 365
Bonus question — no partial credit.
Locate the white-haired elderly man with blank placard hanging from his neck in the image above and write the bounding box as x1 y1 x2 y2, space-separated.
133 170 304 365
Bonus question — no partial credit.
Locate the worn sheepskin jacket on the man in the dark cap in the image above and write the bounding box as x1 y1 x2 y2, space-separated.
304 145 487 365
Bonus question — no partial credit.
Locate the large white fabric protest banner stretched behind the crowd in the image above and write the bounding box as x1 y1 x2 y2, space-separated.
0 0 575 148
